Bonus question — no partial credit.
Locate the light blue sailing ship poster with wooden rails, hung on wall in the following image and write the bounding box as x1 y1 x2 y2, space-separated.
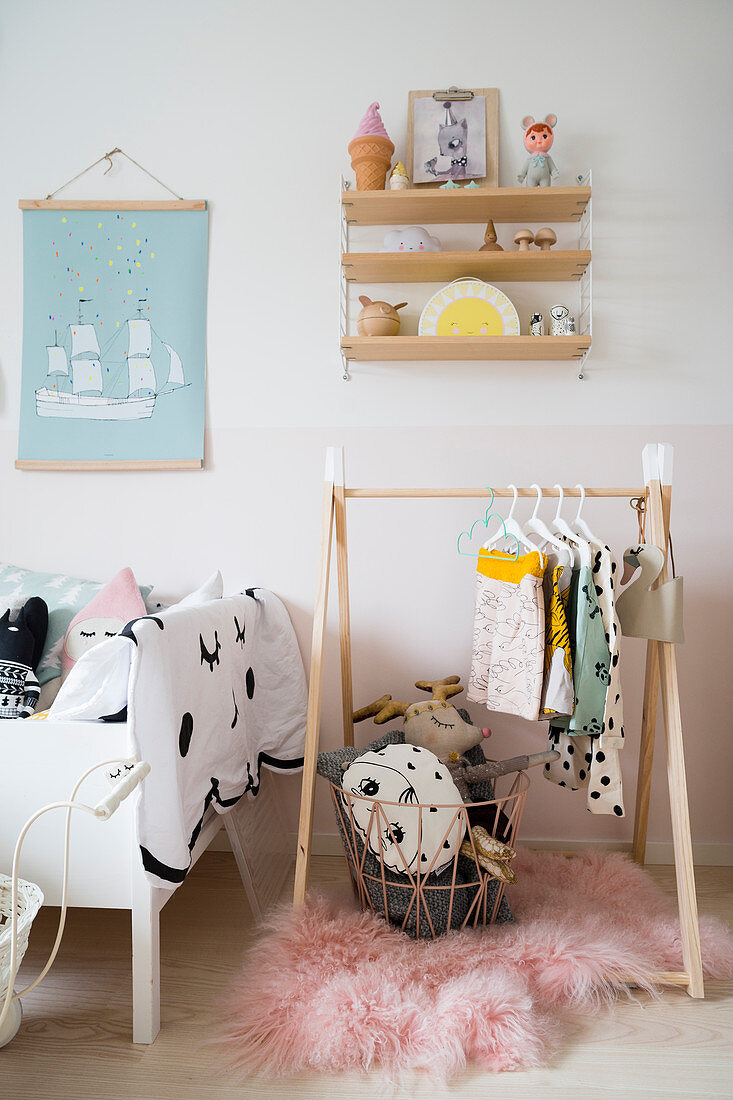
17 202 208 469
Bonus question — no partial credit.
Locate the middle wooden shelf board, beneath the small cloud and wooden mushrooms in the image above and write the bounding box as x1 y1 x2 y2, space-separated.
341 249 591 283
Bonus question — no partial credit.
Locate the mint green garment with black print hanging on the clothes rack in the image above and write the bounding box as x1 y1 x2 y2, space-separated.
550 565 611 734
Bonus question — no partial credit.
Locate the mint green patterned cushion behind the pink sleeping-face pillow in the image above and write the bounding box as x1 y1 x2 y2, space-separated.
0 562 153 684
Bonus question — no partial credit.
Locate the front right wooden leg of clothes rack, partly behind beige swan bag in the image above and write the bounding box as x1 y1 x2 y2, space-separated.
645 444 704 997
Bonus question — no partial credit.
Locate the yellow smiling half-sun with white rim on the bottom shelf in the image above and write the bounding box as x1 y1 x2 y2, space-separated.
417 278 519 338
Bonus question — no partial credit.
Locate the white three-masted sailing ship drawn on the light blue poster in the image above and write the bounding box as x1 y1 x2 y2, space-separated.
35 298 186 420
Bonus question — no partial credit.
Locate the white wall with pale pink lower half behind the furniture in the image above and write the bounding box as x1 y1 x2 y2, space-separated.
0 0 733 843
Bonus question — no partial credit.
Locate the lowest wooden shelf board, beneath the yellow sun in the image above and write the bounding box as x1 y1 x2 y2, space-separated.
341 336 591 363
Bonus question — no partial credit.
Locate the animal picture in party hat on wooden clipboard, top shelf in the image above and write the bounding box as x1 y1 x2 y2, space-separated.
407 88 499 187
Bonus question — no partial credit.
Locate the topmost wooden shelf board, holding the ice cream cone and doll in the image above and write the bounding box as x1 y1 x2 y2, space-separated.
341 187 590 226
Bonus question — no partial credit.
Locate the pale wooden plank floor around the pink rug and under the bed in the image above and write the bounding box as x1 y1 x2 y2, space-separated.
5 853 733 1100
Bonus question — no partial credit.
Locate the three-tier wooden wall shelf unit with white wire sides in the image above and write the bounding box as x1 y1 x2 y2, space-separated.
339 173 592 381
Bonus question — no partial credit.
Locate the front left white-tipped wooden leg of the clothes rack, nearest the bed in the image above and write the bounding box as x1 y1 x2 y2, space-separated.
293 448 335 909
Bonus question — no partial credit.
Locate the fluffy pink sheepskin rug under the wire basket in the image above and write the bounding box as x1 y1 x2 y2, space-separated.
217 850 733 1080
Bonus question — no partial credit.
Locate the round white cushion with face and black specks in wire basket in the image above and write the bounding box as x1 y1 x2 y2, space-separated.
341 745 464 875
